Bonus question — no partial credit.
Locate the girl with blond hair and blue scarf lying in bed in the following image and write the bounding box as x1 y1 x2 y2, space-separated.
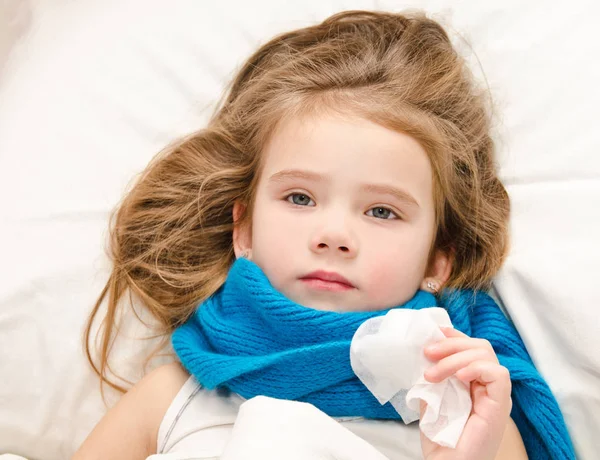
75 11 573 460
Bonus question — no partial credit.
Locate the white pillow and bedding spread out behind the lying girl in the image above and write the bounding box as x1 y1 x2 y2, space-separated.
0 0 600 460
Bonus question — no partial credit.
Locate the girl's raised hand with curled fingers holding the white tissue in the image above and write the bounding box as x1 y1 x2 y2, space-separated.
421 328 512 460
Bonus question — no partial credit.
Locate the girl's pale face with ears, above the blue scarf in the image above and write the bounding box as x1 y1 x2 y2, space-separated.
234 115 450 311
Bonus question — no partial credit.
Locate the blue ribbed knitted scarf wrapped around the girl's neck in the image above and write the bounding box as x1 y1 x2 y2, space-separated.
172 259 575 460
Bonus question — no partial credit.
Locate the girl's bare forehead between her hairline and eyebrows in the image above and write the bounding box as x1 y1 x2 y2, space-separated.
261 114 432 200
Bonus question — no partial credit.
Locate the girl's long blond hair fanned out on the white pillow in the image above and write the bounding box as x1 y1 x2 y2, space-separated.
85 11 509 391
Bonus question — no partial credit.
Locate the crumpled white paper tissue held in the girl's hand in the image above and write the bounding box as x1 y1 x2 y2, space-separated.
350 308 472 448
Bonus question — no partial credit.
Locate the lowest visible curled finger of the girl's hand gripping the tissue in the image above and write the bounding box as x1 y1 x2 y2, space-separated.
456 361 512 404
